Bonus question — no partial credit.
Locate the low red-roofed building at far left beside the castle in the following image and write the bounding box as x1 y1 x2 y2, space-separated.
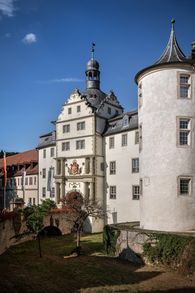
0 149 38 209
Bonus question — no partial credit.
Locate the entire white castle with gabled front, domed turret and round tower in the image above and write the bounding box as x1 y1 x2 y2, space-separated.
37 23 195 232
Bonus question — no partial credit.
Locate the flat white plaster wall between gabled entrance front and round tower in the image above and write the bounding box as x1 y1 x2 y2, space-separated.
105 130 140 224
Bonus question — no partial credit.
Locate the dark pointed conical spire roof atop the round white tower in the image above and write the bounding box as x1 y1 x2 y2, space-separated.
155 19 186 64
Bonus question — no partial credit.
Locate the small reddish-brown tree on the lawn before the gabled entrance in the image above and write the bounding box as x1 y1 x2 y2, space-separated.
61 191 105 255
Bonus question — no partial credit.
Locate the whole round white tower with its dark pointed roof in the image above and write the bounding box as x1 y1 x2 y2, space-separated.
135 21 195 231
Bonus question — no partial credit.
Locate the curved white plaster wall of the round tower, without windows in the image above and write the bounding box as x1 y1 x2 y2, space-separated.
139 65 195 231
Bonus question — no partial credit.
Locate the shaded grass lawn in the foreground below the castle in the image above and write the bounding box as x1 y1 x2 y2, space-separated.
0 234 195 293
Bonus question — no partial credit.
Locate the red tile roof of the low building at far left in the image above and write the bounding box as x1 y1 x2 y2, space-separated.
0 149 38 168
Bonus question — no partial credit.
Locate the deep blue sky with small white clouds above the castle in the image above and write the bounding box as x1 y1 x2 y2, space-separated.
0 0 195 151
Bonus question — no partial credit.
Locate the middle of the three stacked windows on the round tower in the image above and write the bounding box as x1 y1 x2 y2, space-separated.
177 118 191 146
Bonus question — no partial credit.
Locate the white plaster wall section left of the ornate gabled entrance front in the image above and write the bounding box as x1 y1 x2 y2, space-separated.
38 146 56 203
